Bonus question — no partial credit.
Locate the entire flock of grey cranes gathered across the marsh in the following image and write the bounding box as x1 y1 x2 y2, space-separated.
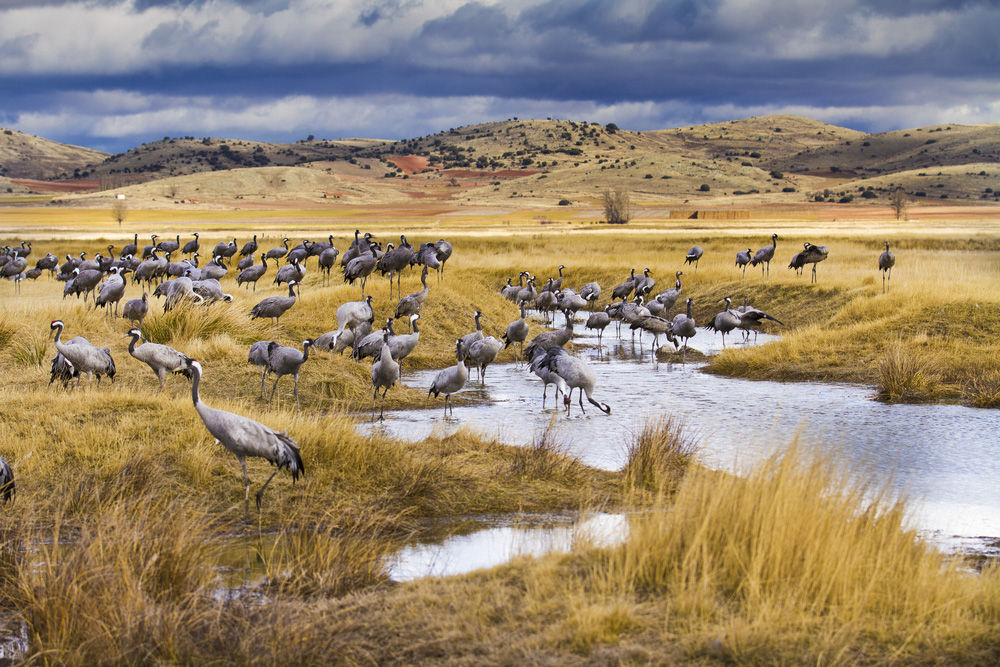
0 230 895 512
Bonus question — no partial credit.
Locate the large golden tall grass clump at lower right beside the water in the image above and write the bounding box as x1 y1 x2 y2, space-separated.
592 443 1000 662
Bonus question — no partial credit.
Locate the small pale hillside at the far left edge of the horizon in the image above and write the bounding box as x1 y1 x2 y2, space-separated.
0 128 107 180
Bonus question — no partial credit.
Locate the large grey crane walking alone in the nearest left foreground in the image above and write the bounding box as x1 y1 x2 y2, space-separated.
188 361 305 518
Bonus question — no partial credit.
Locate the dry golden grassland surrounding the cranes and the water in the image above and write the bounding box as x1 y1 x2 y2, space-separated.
0 207 1000 664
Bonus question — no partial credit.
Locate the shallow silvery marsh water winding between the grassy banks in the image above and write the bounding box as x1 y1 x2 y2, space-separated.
360 316 1000 578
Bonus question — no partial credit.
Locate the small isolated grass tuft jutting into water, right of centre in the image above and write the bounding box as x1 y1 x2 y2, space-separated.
623 416 697 493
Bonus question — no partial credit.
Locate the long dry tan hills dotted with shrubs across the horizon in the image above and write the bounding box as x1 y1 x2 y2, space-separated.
1 115 1000 206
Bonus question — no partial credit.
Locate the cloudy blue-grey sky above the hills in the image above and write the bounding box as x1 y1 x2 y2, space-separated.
0 0 1000 152
